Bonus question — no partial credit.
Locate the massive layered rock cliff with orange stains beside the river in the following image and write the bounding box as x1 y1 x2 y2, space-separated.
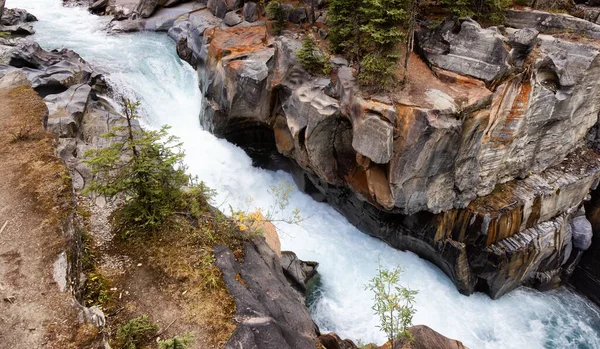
169 6 600 298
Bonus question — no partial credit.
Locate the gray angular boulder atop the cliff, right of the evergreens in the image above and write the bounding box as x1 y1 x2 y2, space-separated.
417 19 509 82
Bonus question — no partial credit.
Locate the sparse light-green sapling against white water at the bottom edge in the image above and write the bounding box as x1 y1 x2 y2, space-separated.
367 262 418 349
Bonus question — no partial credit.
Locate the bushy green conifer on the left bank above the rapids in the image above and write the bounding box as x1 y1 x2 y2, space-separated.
84 99 191 235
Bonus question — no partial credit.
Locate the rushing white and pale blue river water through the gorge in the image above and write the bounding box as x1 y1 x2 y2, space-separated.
7 0 600 349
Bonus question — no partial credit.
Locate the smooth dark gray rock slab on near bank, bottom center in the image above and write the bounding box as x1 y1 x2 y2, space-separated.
215 238 317 349
